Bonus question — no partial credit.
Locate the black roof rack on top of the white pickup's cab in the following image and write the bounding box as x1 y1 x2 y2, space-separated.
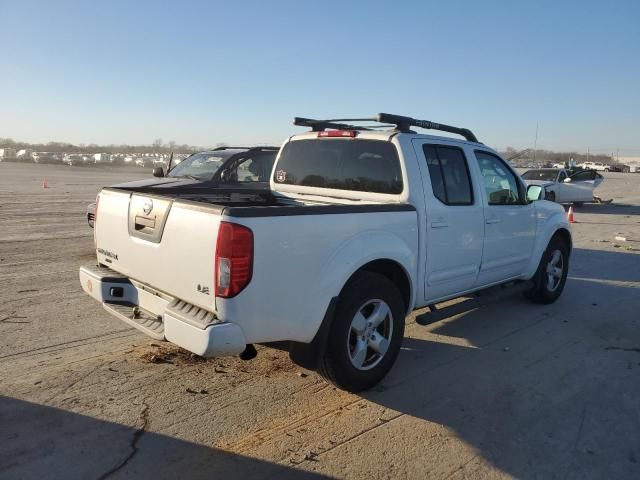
293 113 480 143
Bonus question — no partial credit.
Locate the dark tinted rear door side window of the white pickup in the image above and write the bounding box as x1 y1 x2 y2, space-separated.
422 145 473 205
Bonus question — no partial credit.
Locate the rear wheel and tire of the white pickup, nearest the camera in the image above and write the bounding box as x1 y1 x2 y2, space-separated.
318 272 406 392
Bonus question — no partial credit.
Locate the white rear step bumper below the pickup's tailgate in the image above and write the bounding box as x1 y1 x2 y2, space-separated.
79 265 246 357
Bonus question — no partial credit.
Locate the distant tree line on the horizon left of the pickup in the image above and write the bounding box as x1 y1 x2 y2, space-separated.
0 138 226 153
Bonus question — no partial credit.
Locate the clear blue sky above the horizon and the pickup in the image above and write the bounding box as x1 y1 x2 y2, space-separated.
0 0 640 155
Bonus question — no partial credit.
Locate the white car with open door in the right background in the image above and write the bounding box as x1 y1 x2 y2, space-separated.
522 168 604 205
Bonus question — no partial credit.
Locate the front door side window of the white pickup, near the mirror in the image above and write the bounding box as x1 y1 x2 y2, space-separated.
475 150 522 205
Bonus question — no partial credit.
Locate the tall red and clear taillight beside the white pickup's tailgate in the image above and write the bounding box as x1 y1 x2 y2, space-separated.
215 222 253 298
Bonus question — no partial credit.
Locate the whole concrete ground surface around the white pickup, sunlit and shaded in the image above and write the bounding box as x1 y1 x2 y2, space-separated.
0 163 640 479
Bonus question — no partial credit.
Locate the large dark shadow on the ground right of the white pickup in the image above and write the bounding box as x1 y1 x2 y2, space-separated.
365 249 640 479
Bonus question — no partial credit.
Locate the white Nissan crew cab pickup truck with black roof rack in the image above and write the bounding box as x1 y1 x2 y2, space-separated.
80 114 572 391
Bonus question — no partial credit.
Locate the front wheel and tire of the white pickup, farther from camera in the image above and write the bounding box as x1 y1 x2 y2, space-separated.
524 237 569 304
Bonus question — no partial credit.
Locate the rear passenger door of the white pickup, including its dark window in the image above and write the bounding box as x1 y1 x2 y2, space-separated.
413 139 484 301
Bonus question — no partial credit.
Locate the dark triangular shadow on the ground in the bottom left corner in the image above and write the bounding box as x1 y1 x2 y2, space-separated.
0 396 328 479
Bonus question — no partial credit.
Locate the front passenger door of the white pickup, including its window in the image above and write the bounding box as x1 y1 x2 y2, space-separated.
475 150 536 287
